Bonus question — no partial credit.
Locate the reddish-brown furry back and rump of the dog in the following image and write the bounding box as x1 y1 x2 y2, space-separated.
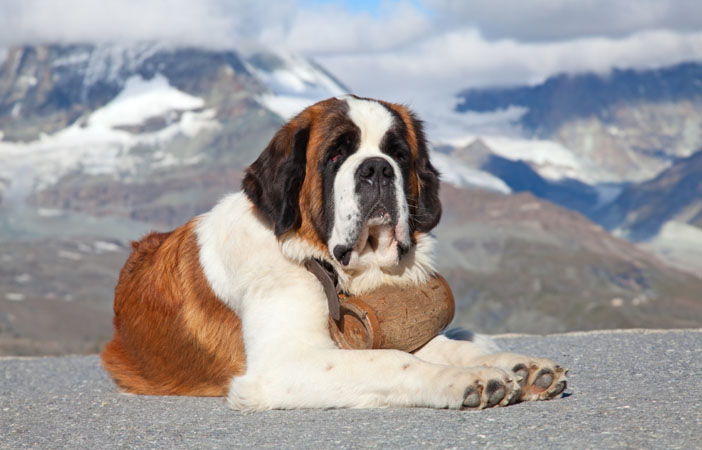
102 221 245 396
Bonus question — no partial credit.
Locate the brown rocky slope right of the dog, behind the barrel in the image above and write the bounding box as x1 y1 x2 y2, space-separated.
436 185 702 333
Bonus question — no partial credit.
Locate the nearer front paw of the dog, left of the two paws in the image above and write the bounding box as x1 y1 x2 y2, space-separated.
461 367 520 409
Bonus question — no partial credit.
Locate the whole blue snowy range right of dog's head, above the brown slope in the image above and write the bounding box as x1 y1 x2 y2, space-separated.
445 63 702 276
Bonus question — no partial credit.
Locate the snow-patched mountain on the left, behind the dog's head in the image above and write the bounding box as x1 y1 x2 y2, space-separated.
0 44 345 211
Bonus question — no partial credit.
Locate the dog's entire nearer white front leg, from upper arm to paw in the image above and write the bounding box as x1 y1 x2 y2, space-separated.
228 282 519 410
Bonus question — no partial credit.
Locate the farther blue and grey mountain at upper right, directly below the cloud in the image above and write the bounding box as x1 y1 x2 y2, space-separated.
456 63 702 183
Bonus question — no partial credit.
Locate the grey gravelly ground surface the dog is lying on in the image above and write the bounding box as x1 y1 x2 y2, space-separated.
0 330 702 449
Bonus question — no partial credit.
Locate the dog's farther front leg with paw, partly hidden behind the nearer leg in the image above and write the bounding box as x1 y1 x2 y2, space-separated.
414 335 568 400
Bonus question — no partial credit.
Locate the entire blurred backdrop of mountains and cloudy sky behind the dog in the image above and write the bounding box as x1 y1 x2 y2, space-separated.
0 0 702 355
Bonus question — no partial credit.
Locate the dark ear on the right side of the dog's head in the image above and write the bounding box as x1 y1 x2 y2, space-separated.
412 117 441 233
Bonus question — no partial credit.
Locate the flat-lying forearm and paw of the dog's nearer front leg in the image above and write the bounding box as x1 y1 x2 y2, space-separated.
228 348 519 410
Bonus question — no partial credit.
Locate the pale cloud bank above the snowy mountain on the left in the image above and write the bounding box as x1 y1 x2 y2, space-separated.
0 0 296 47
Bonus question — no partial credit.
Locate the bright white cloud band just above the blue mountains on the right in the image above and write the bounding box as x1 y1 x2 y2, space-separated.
320 28 702 101
